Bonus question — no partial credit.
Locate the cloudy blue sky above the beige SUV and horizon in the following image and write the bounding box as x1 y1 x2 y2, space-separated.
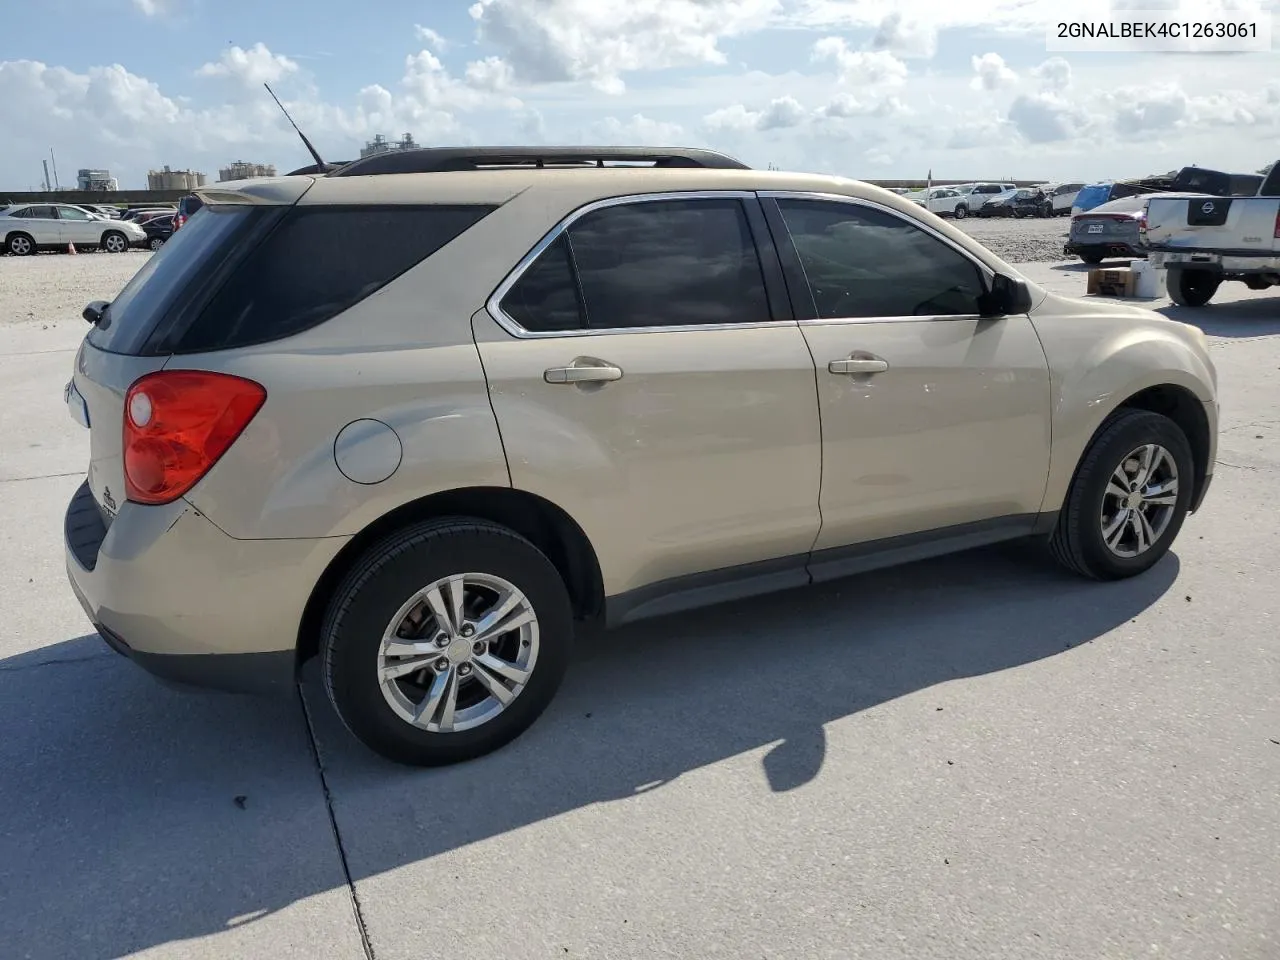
0 0 1280 189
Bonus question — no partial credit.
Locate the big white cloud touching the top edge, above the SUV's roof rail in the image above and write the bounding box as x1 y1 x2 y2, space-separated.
470 0 781 93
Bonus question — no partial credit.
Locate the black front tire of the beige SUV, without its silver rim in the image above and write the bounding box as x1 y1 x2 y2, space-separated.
1050 410 1196 580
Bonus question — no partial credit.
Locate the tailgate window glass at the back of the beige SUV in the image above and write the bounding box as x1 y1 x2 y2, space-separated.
87 206 261 355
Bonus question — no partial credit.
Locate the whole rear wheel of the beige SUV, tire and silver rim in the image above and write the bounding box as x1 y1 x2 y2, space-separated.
321 518 573 767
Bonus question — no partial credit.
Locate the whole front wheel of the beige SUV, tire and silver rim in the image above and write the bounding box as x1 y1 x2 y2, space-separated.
1050 410 1196 580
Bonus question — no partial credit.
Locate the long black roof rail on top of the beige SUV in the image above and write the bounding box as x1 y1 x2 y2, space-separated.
329 146 750 177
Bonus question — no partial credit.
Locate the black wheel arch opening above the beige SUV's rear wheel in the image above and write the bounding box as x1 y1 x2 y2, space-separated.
297 486 604 664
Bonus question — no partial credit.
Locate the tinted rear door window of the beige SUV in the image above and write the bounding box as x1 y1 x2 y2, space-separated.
568 200 772 329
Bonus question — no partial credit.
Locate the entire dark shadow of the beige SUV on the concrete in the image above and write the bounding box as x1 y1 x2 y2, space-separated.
0 545 1179 957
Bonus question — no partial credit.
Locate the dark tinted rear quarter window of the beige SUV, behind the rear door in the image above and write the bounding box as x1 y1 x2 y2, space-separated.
177 205 494 352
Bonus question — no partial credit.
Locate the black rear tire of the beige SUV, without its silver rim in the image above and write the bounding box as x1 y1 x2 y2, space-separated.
320 517 573 767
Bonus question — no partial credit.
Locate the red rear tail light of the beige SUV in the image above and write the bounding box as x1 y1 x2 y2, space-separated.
124 370 266 503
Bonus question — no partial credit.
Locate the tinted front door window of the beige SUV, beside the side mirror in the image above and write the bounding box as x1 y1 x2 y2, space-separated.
778 200 984 319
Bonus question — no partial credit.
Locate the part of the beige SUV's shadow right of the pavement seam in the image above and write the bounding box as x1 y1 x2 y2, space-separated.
306 544 1179 881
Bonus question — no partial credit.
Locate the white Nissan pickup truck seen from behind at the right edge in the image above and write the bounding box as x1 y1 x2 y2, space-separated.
1142 161 1280 307
